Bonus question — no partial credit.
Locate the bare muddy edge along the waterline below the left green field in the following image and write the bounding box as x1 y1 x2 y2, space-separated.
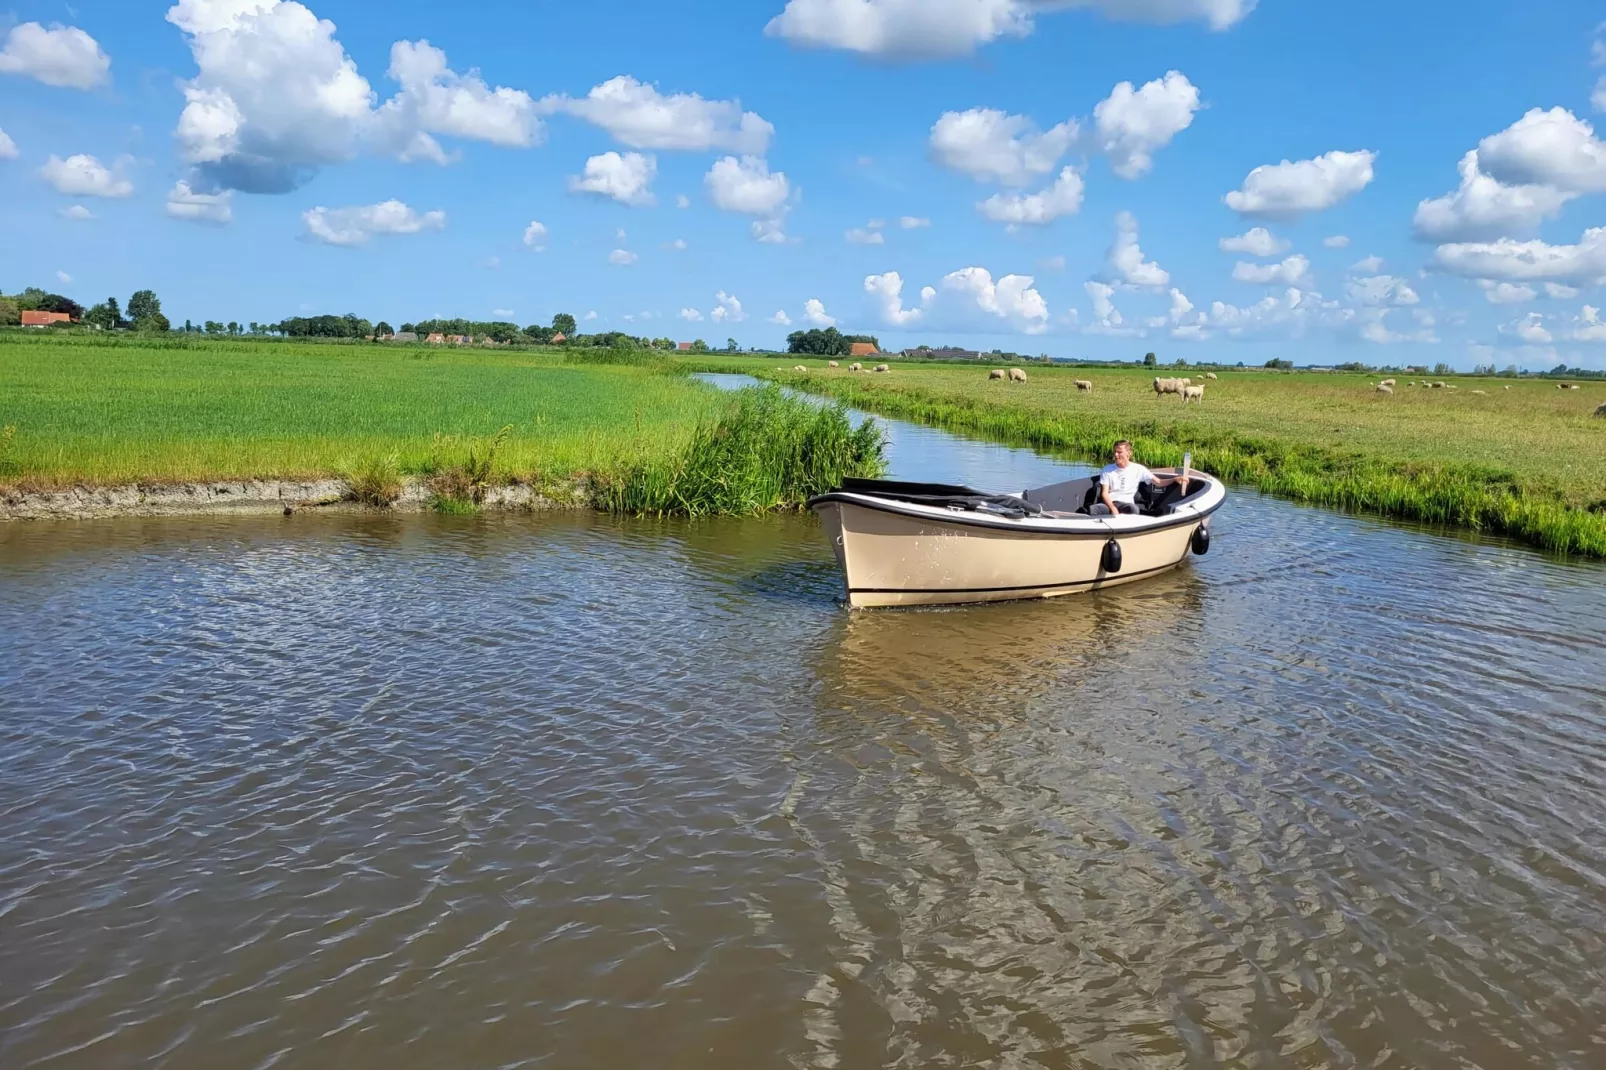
0 479 591 522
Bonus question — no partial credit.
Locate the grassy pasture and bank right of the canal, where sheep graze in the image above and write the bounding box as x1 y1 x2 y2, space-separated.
708 360 1606 557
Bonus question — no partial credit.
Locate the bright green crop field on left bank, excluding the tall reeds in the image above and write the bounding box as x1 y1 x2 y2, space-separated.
0 331 726 487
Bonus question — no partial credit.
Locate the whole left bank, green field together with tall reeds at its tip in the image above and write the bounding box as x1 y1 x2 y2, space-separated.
0 333 880 513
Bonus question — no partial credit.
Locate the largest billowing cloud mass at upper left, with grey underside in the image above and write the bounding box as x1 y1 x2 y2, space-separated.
167 0 543 193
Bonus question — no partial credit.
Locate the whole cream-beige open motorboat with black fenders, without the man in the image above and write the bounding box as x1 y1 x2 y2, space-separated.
808 469 1227 607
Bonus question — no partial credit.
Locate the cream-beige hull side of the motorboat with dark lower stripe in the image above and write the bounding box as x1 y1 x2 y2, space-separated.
814 501 1206 607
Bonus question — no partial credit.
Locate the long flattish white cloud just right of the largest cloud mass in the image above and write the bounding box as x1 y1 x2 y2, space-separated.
541 74 776 156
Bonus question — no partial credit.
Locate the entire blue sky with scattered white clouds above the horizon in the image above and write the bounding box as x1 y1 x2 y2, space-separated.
0 0 1606 366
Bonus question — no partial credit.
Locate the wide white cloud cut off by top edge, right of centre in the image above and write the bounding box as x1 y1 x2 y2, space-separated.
764 0 1256 58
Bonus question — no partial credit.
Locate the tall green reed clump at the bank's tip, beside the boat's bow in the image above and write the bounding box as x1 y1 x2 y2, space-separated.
593 387 885 516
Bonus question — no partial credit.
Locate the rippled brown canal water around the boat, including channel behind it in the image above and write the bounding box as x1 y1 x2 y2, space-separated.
0 387 1606 1070
